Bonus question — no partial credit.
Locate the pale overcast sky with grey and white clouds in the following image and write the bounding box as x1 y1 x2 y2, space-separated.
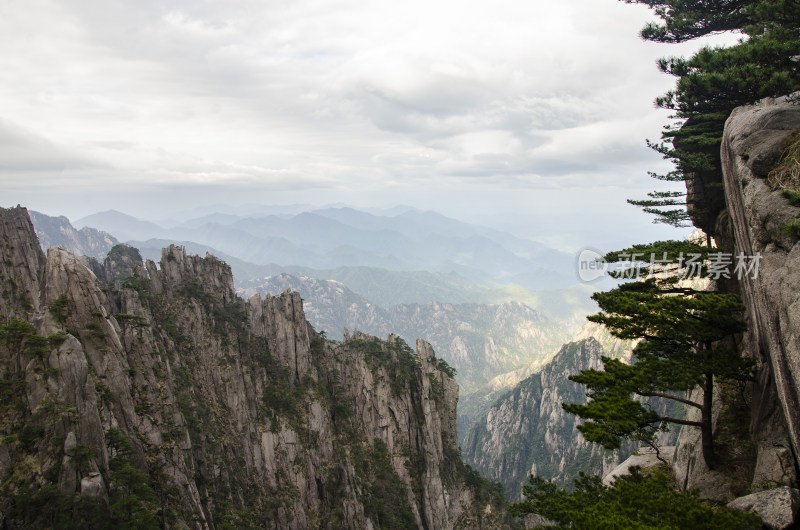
0 0 736 248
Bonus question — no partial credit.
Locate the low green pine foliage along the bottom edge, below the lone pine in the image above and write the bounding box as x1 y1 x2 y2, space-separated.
511 467 761 530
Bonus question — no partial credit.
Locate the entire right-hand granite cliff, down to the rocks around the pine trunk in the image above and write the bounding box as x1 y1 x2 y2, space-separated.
674 94 800 512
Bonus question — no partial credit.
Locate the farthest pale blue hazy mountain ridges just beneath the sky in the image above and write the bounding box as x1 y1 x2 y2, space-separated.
76 208 576 290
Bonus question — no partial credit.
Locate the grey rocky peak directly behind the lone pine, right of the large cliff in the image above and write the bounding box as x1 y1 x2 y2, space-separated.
459 323 682 499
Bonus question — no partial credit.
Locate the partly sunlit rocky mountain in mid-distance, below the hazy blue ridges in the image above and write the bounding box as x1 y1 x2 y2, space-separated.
239 274 569 395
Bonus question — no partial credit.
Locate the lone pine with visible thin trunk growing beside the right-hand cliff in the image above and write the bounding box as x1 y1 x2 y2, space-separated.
563 241 753 468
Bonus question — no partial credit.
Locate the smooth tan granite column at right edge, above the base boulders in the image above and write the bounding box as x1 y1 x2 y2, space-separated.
719 101 800 470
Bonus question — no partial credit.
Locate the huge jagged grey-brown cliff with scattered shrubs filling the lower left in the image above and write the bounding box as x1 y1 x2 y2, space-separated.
0 208 505 529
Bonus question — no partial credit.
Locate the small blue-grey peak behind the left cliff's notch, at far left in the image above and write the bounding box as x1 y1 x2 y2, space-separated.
29 211 119 261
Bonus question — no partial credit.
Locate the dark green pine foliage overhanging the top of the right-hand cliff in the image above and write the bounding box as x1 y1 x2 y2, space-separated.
627 0 800 232
